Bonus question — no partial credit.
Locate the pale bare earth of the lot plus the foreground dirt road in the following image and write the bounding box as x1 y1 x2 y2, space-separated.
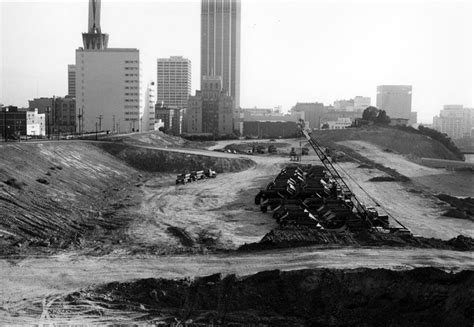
0 140 474 324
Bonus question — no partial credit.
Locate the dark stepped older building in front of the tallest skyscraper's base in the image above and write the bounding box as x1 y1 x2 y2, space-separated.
186 76 234 136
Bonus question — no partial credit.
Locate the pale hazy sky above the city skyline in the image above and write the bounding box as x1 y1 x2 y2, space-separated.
0 0 474 123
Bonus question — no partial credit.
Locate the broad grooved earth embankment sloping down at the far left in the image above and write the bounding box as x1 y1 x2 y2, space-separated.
0 142 138 254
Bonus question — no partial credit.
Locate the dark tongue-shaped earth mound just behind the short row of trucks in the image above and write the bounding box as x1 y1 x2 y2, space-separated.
97 143 255 173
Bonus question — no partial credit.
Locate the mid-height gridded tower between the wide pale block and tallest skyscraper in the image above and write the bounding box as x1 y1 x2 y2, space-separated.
156 56 191 108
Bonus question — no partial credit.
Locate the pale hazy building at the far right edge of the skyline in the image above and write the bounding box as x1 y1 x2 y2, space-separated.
433 105 474 140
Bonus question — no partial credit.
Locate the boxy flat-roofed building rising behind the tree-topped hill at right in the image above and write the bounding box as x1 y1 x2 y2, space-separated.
377 85 411 119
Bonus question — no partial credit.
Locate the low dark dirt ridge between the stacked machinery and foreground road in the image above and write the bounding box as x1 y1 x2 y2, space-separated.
239 226 474 251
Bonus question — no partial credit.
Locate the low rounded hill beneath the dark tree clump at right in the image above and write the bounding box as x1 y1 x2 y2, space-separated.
312 126 459 161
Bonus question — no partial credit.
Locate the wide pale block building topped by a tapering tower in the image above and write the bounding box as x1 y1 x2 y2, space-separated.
76 0 144 132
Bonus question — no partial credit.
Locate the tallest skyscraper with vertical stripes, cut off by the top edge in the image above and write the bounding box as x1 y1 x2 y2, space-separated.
201 0 240 108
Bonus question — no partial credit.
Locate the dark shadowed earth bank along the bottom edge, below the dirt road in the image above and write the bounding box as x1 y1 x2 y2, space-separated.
45 268 474 326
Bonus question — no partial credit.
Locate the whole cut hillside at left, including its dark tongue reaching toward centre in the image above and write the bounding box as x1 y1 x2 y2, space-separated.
0 141 254 254
